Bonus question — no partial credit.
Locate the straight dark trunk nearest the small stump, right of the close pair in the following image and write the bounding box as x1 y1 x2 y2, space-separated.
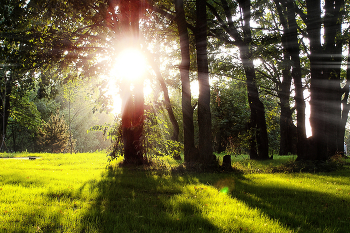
195 0 215 166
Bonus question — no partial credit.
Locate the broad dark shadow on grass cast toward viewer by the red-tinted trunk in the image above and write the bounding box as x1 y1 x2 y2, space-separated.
80 168 219 233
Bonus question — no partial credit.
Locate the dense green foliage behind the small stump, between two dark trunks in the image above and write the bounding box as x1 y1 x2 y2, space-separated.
211 80 250 154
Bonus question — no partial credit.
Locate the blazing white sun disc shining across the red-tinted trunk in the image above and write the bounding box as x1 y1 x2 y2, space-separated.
111 48 146 82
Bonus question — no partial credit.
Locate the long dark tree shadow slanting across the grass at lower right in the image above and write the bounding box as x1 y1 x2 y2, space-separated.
197 171 350 232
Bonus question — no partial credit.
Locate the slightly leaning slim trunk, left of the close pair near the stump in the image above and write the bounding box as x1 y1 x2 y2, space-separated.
174 0 198 162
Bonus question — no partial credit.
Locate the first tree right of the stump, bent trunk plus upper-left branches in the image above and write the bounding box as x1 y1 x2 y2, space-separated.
208 0 269 160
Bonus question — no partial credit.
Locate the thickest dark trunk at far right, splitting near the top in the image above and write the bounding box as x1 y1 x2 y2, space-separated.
304 0 344 160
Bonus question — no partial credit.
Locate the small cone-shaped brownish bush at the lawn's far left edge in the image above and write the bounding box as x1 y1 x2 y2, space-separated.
37 112 74 153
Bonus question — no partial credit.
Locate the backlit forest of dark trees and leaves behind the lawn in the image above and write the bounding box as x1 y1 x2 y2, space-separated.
0 0 350 164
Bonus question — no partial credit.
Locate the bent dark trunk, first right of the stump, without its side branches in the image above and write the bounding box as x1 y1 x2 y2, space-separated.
238 0 269 160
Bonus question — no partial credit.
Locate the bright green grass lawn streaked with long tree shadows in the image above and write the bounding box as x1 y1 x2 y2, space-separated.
0 152 350 233
